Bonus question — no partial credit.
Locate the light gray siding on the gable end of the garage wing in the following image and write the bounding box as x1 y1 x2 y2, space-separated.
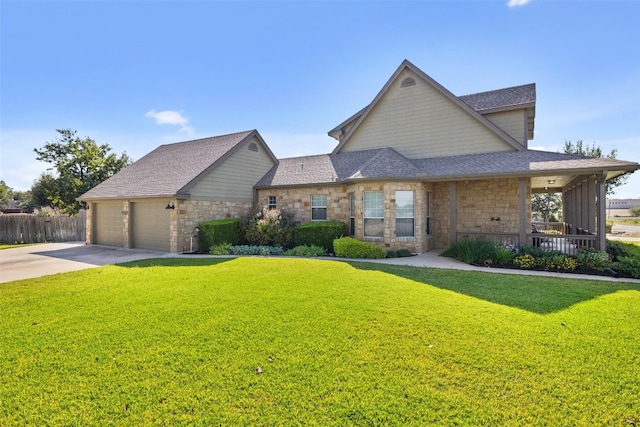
189 138 275 201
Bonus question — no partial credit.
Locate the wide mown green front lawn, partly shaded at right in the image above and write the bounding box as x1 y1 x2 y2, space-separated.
0 258 640 426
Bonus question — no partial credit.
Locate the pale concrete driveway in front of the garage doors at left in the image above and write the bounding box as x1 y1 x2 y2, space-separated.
0 242 172 283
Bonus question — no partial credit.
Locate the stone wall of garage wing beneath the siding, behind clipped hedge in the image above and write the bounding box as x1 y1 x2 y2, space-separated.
176 200 253 252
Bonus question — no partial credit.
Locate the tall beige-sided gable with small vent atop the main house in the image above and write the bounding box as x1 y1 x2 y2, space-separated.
334 61 524 159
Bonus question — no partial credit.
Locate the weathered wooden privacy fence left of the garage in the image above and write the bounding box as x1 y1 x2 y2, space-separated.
0 211 86 243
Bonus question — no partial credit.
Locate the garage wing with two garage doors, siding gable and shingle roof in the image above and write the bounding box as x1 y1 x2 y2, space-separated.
79 130 277 252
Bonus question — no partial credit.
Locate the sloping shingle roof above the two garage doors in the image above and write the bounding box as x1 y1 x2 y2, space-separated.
80 130 256 200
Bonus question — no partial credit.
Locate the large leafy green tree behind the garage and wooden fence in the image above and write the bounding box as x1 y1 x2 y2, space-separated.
32 129 131 214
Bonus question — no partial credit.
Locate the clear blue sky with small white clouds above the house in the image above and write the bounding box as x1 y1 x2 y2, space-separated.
0 0 640 198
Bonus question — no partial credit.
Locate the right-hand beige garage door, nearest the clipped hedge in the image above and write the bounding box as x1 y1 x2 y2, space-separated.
131 201 171 252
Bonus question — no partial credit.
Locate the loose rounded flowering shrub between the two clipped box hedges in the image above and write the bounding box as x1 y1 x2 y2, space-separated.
240 207 295 247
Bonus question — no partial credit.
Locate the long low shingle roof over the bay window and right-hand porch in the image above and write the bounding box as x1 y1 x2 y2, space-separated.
256 148 638 187
